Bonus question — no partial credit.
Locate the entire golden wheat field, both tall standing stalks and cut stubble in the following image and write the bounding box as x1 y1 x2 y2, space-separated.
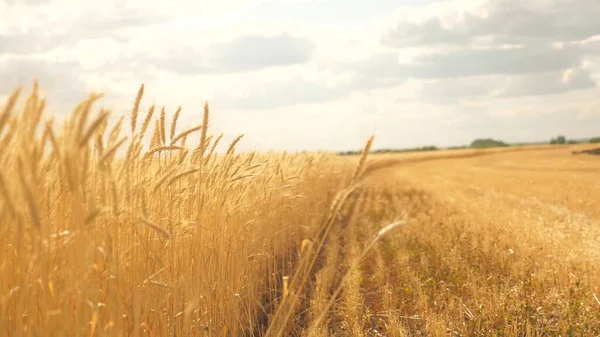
0 84 600 337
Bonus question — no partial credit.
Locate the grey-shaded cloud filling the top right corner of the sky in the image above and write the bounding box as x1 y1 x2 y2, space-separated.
385 0 600 47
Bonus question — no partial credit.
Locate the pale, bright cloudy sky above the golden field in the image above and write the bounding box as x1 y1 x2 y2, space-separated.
0 0 600 151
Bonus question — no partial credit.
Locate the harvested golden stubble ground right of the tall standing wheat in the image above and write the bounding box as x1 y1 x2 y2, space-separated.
295 150 600 336
